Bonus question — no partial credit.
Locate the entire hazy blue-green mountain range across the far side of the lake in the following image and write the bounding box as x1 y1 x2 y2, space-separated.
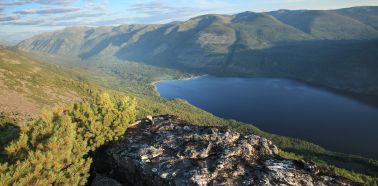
17 7 378 95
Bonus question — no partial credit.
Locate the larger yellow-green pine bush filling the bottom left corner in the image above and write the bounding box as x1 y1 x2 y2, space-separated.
0 109 92 185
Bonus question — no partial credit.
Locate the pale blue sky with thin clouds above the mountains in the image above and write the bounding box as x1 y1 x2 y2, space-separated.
0 0 378 42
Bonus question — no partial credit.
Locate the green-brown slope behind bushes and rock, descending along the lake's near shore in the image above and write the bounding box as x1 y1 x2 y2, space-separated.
0 48 378 183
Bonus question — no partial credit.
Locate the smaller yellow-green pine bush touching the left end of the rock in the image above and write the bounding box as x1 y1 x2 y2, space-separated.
70 93 136 150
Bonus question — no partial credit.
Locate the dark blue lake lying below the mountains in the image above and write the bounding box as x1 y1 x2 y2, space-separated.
157 76 378 159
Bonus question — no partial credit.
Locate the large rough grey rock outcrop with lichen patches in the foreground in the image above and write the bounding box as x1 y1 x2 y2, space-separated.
92 115 355 185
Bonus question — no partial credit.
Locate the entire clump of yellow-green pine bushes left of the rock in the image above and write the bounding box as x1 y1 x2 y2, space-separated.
0 94 136 185
